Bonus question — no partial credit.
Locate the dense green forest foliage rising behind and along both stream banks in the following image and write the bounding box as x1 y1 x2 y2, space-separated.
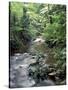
9 2 66 85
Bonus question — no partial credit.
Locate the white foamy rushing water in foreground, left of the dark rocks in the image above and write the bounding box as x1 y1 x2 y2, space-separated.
9 53 54 88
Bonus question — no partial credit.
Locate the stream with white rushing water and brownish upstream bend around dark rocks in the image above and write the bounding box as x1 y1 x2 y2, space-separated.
9 37 55 88
